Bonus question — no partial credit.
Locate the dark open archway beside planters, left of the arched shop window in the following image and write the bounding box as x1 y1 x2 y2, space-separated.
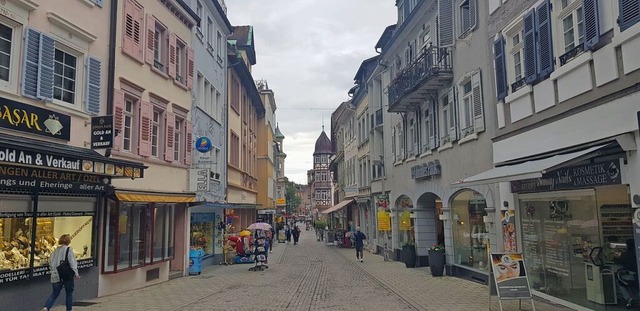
414 192 445 266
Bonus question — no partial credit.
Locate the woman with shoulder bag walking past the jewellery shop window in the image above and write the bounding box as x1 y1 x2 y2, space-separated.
42 234 80 311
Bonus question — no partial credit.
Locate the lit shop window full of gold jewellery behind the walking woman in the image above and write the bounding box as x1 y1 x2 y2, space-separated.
0 196 95 283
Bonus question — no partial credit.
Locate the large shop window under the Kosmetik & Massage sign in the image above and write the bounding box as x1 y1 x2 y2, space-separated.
518 190 600 305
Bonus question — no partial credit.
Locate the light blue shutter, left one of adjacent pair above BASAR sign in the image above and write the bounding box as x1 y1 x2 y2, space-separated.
21 28 40 98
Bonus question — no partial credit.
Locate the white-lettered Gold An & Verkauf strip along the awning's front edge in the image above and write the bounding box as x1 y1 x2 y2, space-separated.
0 147 142 178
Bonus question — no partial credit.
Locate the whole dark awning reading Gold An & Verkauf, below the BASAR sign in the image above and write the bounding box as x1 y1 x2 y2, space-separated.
0 133 147 178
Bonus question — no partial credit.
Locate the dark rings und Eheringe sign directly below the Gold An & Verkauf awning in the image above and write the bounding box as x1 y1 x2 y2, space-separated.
0 164 107 192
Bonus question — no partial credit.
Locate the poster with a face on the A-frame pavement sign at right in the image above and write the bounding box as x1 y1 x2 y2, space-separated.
491 253 531 299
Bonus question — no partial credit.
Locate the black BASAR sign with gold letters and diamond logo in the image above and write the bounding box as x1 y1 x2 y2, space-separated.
0 97 71 141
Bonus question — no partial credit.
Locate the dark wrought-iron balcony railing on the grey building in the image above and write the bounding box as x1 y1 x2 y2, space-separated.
388 46 453 111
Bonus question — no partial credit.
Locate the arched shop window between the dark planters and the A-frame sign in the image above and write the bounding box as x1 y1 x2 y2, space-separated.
451 190 489 270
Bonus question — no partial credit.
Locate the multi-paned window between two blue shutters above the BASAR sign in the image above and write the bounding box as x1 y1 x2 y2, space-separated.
53 49 77 104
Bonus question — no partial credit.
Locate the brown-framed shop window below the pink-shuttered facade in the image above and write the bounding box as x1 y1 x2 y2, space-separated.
103 202 174 272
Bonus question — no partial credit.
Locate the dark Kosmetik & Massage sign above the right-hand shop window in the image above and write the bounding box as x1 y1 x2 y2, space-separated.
511 160 622 193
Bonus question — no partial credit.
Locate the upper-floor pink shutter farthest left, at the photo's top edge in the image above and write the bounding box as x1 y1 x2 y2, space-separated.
122 0 144 62
